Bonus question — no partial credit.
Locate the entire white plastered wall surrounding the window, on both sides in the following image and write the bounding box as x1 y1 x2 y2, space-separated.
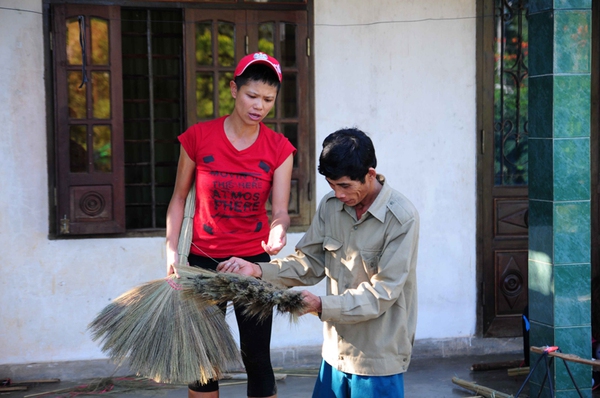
0 0 476 364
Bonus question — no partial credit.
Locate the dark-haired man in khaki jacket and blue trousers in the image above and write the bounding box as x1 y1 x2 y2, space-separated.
218 129 419 398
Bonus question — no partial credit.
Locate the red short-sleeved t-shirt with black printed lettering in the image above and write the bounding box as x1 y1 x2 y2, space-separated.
179 116 296 258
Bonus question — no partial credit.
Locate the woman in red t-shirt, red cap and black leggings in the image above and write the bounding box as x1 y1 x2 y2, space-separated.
167 53 296 398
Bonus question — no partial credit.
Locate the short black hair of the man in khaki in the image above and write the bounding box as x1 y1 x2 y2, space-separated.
319 128 377 183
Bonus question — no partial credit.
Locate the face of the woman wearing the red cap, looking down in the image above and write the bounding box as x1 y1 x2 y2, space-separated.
231 80 277 124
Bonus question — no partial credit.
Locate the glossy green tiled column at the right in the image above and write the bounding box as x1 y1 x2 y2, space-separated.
529 0 592 397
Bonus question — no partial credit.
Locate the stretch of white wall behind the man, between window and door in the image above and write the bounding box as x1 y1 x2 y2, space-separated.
314 0 476 339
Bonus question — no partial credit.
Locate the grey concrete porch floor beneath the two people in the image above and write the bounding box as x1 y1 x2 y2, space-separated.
0 354 540 398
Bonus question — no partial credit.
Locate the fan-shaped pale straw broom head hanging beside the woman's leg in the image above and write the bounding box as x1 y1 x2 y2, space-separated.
88 267 240 383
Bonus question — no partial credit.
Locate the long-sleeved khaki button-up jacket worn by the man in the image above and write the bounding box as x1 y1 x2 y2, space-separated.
260 176 419 376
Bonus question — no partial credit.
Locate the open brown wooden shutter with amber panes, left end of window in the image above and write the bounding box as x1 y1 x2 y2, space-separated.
54 5 125 235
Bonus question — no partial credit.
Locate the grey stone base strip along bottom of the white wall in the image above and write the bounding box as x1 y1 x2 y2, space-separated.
0 337 523 381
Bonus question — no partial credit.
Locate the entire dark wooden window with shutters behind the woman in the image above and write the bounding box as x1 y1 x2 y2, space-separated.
52 1 315 236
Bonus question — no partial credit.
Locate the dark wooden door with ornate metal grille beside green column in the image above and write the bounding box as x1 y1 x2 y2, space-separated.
477 0 528 337
